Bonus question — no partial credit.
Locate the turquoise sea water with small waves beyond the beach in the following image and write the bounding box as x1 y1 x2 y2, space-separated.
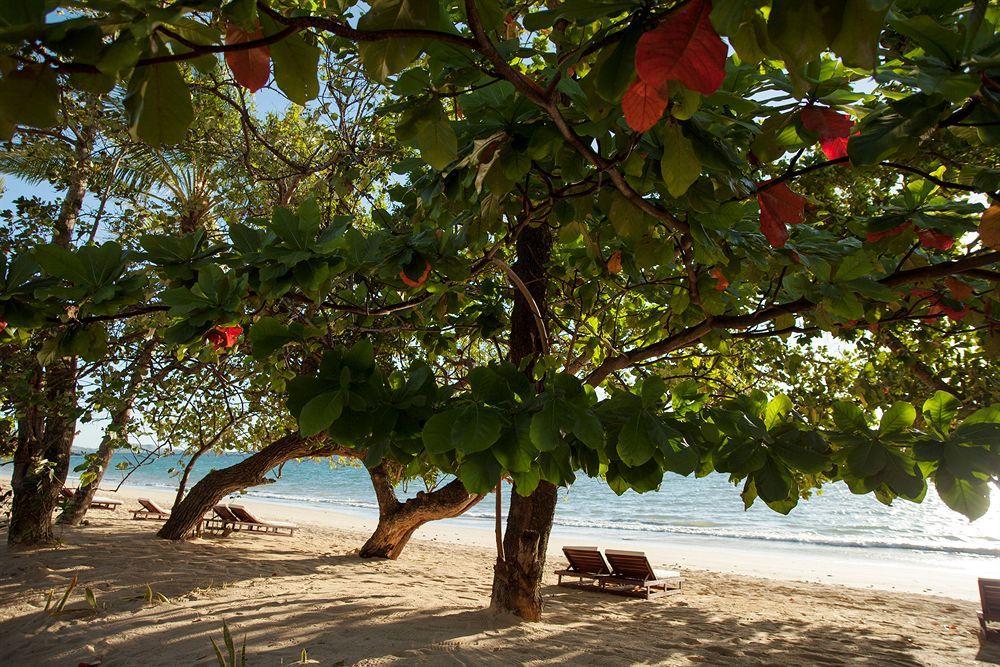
71 454 1000 557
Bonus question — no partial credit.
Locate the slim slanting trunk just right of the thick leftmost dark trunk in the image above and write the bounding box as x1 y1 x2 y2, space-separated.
59 339 156 526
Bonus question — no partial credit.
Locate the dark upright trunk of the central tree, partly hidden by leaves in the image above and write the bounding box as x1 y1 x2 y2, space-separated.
490 225 556 621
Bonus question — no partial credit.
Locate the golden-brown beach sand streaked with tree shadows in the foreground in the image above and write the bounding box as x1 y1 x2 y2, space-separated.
0 489 1000 665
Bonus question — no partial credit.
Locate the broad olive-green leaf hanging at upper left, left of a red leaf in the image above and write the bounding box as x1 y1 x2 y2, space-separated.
125 63 194 146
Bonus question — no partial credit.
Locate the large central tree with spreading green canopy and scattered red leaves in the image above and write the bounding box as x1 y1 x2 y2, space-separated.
0 0 1000 619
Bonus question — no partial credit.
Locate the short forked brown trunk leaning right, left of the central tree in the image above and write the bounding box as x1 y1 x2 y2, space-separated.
359 463 485 560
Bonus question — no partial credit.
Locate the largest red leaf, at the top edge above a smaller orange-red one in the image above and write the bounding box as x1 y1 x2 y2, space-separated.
635 0 726 95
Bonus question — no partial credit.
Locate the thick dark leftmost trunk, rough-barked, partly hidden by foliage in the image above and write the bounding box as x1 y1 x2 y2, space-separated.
7 122 96 548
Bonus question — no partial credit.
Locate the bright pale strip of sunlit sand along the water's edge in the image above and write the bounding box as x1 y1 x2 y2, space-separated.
50 484 1000 600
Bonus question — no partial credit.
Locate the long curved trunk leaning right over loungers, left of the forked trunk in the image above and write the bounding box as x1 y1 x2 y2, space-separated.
157 433 345 540
